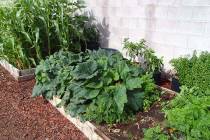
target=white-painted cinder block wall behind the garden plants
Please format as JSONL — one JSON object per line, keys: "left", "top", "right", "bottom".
{"left": 87, "top": 0, "right": 210, "bottom": 68}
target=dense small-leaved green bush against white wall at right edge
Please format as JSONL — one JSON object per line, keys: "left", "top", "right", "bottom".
{"left": 171, "top": 52, "right": 210, "bottom": 92}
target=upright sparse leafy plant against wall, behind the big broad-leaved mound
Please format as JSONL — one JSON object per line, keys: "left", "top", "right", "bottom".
{"left": 124, "top": 39, "right": 163, "bottom": 73}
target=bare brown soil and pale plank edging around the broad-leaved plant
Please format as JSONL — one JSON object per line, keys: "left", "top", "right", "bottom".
{"left": 49, "top": 86, "right": 176, "bottom": 140}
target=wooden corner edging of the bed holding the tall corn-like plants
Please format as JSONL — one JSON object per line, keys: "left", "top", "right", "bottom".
{"left": 0, "top": 60, "right": 35, "bottom": 81}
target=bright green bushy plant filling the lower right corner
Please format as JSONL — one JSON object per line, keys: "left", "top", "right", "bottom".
{"left": 145, "top": 86, "right": 210, "bottom": 140}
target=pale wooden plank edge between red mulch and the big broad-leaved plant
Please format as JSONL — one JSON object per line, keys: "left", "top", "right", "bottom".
{"left": 48, "top": 97, "right": 110, "bottom": 140}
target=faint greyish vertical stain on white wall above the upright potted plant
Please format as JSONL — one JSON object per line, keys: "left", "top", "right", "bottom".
{"left": 145, "top": 4, "right": 156, "bottom": 42}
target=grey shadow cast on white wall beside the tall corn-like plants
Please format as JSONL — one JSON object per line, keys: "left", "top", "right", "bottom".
{"left": 86, "top": 10, "right": 110, "bottom": 48}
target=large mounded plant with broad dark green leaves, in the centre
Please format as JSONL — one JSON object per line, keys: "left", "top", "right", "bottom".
{"left": 33, "top": 49, "right": 159, "bottom": 123}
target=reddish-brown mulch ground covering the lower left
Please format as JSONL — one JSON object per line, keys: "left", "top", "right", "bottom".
{"left": 0, "top": 66, "right": 87, "bottom": 140}
